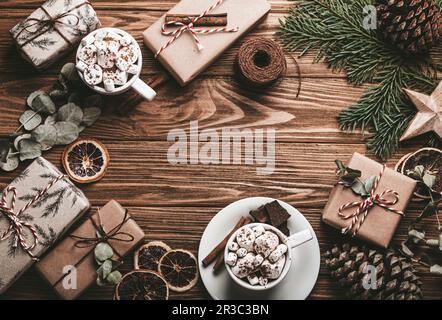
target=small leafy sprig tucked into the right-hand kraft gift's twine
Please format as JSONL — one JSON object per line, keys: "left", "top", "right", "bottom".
{"left": 335, "top": 160, "right": 376, "bottom": 198}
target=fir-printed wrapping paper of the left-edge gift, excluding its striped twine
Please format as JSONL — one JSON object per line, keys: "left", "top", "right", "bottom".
{"left": 0, "top": 158, "right": 90, "bottom": 293}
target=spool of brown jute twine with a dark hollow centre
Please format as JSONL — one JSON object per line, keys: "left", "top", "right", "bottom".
{"left": 236, "top": 38, "right": 287, "bottom": 88}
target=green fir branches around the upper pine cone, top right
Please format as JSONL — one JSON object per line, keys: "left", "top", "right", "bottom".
{"left": 276, "top": 0, "right": 442, "bottom": 159}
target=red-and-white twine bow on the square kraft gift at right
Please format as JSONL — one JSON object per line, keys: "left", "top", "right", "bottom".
{"left": 338, "top": 165, "right": 404, "bottom": 236}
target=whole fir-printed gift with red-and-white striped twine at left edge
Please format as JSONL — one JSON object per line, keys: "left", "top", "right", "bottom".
{"left": 0, "top": 158, "right": 89, "bottom": 293}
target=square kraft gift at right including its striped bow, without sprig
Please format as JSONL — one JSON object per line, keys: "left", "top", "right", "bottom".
{"left": 322, "top": 153, "right": 416, "bottom": 248}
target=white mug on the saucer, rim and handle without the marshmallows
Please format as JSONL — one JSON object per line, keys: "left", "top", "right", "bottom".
{"left": 224, "top": 223, "right": 313, "bottom": 291}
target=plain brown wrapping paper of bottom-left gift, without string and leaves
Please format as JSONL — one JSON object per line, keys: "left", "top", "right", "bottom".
{"left": 36, "top": 200, "right": 144, "bottom": 300}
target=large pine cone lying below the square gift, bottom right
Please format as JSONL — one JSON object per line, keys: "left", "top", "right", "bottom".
{"left": 325, "top": 243, "right": 422, "bottom": 300}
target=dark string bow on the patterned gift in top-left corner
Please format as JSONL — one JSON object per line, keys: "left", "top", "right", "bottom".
{"left": 15, "top": 1, "right": 90, "bottom": 47}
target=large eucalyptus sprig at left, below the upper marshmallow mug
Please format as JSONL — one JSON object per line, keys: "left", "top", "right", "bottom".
{"left": 0, "top": 63, "right": 102, "bottom": 171}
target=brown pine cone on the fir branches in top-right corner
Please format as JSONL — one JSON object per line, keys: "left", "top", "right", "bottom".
{"left": 376, "top": 0, "right": 442, "bottom": 54}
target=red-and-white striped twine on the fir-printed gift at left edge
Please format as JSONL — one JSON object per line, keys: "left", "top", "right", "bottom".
{"left": 0, "top": 175, "right": 66, "bottom": 261}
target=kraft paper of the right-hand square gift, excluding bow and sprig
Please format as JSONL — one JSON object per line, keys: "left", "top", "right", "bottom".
{"left": 322, "top": 153, "right": 416, "bottom": 248}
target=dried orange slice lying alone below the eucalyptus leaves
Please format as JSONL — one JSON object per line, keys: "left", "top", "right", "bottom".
{"left": 62, "top": 138, "right": 109, "bottom": 183}
